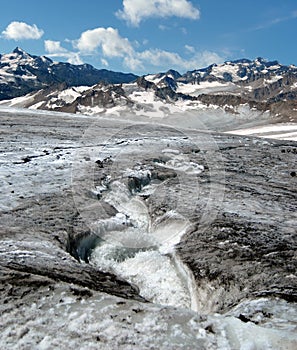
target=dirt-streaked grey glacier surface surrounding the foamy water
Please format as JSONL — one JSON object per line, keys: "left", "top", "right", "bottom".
{"left": 0, "top": 109, "right": 297, "bottom": 349}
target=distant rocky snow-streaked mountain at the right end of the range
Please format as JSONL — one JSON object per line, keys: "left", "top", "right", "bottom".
{"left": 179, "top": 58, "right": 297, "bottom": 102}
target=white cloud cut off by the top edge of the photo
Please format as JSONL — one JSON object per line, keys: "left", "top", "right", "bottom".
{"left": 116, "top": 0, "right": 200, "bottom": 26}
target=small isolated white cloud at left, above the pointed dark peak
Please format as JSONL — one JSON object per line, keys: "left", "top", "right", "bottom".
{"left": 2, "top": 21, "right": 44, "bottom": 40}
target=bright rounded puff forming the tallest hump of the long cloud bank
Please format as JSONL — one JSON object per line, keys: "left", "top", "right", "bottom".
{"left": 75, "top": 27, "right": 133, "bottom": 57}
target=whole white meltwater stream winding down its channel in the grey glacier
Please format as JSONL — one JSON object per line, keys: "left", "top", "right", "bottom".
{"left": 90, "top": 181, "right": 197, "bottom": 311}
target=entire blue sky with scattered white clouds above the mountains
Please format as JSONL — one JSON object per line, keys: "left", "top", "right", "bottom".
{"left": 0, "top": 0, "right": 297, "bottom": 74}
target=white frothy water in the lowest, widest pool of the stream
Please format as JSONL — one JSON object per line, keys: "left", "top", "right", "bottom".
{"left": 92, "top": 243, "right": 191, "bottom": 308}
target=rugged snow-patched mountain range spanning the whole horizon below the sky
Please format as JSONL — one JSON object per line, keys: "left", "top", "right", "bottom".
{"left": 0, "top": 48, "right": 297, "bottom": 128}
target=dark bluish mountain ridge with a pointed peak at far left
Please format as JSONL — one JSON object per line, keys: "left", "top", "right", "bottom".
{"left": 0, "top": 47, "right": 137, "bottom": 100}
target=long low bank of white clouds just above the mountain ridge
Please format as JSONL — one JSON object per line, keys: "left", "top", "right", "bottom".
{"left": 44, "top": 27, "right": 224, "bottom": 73}
